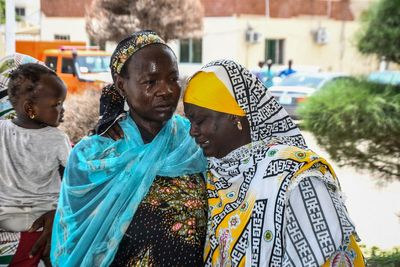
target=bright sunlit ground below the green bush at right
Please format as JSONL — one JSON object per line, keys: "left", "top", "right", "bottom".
{"left": 302, "top": 131, "right": 400, "bottom": 249}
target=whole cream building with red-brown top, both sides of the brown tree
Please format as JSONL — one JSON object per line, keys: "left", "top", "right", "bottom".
{"left": 3, "top": 0, "right": 379, "bottom": 76}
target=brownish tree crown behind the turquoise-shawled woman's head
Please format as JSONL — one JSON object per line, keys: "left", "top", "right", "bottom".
{"left": 86, "top": 0, "right": 203, "bottom": 42}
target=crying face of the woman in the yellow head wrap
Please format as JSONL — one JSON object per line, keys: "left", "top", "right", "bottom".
{"left": 184, "top": 103, "right": 251, "bottom": 158}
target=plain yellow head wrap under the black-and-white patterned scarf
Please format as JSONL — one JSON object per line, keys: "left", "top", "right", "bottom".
{"left": 183, "top": 71, "right": 246, "bottom": 116}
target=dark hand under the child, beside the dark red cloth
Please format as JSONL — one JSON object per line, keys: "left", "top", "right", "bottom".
{"left": 29, "top": 210, "right": 56, "bottom": 266}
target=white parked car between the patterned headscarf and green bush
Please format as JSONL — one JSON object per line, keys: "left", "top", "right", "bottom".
{"left": 268, "top": 72, "right": 350, "bottom": 119}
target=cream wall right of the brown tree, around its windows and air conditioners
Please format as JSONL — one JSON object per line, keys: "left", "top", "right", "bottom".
{"left": 176, "top": 16, "right": 384, "bottom": 75}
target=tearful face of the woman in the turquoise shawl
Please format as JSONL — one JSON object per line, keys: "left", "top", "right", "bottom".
{"left": 117, "top": 44, "right": 181, "bottom": 124}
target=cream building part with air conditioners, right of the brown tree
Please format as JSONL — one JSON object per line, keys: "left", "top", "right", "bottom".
{"left": 173, "top": 0, "right": 378, "bottom": 74}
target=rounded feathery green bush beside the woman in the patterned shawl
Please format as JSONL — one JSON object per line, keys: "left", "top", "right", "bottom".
{"left": 300, "top": 79, "right": 400, "bottom": 180}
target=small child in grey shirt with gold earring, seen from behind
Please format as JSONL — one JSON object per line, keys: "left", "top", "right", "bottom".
{"left": 0, "top": 63, "right": 71, "bottom": 266}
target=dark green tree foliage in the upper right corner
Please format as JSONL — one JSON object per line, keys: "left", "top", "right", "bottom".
{"left": 357, "top": 0, "right": 400, "bottom": 64}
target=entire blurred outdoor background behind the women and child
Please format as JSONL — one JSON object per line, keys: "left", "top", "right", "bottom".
{"left": 0, "top": 0, "right": 400, "bottom": 266}
